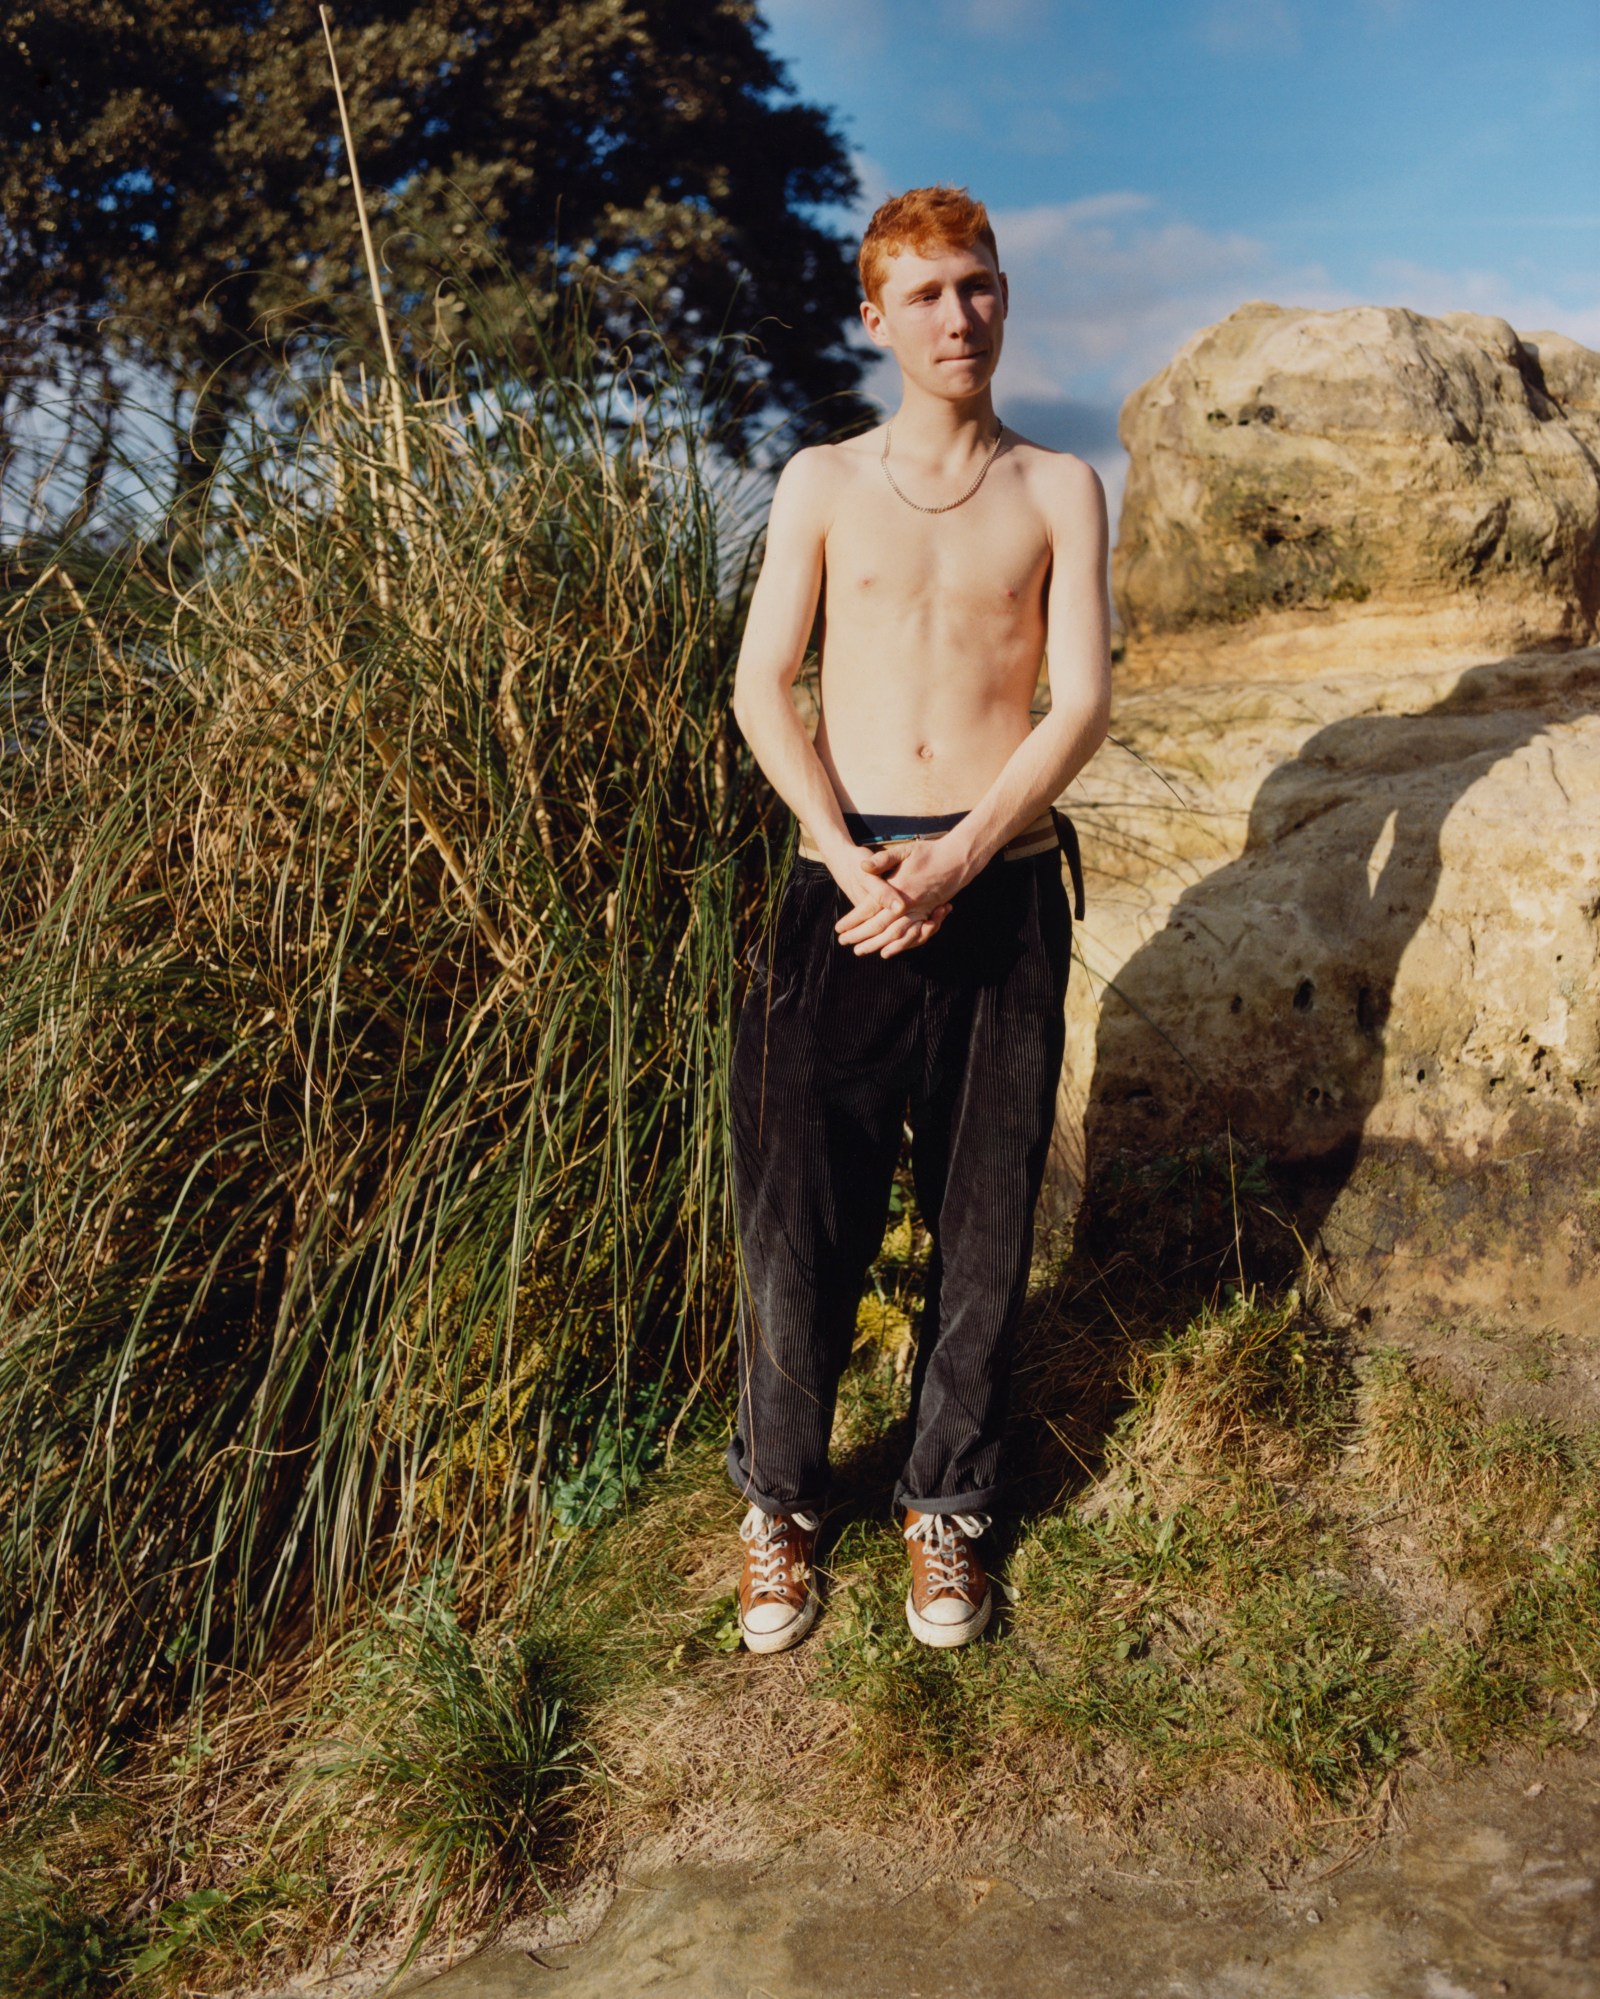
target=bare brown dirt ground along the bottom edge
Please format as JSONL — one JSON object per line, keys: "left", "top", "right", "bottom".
{"left": 247, "top": 1747, "right": 1600, "bottom": 1999}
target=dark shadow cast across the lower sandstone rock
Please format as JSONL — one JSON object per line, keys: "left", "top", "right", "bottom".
{"left": 1018, "top": 652, "right": 1600, "bottom": 1503}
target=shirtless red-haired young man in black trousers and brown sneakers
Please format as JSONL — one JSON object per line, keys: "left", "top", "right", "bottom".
{"left": 728, "top": 188, "right": 1110, "bottom": 1651}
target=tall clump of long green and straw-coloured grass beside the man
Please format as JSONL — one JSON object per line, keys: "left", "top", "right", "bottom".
{"left": 0, "top": 326, "right": 764, "bottom": 1801}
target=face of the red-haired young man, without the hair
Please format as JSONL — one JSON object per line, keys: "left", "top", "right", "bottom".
{"left": 862, "top": 244, "right": 1006, "bottom": 402}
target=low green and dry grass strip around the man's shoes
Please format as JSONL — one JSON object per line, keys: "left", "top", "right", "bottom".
{"left": 0, "top": 1247, "right": 1600, "bottom": 1995}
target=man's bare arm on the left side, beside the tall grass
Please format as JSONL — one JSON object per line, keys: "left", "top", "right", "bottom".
{"left": 734, "top": 450, "right": 946, "bottom": 950}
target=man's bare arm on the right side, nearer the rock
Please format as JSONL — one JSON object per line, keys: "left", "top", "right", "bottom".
{"left": 840, "top": 458, "right": 1112, "bottom": 952}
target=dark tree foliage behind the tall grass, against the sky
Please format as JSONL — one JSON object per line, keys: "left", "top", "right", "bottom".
{"left": 0, "top": 0, "right": 858, "bottom": 445}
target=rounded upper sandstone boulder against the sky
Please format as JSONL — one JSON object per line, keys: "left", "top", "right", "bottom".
{"left": 1112, "top": 304, "right": 1600, "bottom": 678}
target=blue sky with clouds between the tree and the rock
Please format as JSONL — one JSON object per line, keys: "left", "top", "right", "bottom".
{"left": 762, "top": 0, "right": 1600, "bottom": 503}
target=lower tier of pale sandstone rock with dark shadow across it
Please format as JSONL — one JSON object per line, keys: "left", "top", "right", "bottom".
{"left": 1058, "top": 650, "right": 1600, "bottom": 1293}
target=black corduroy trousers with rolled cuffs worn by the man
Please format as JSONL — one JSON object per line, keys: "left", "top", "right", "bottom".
{"left": 728, "top": 854, "right": 1072, "bottom": 1513}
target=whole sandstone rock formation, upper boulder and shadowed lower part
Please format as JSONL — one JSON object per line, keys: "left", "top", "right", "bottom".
{"left": 1054, "top": 306, "right": 1600, "bottom": 1319}
